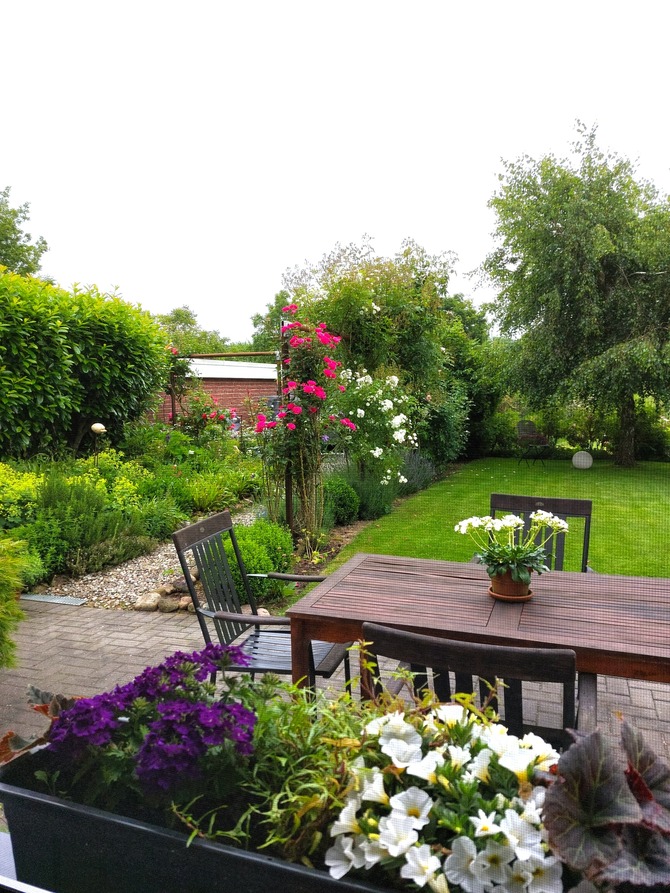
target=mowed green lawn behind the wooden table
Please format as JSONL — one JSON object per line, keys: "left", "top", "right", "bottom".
{"left": 329, "top": 459, "right": 670, "bottom": 577}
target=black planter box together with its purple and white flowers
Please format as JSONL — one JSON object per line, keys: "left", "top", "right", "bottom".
{"left": 0, "top": 645, "right": 572, "bottom": 893}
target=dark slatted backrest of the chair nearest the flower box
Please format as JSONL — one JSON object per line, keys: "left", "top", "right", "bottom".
{"left": 363, "top": 623, "right": 577, "bottom": 743}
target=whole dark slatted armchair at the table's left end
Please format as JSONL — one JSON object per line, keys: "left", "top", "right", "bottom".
{"left": 172, "top": 511, "right": 351, "bottom": 687}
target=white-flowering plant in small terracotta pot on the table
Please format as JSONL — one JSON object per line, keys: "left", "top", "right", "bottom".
{"left": 454, "top": 511, "right": 568, "bottom": 601}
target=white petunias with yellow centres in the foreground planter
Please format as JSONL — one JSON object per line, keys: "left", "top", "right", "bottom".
{"left": 326, "top": 704, "right": 563, "bottom": 893}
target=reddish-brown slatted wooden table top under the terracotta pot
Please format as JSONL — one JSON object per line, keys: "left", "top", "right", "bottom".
{"left": 287, "top": 553, "right": 670, "bottom": 682}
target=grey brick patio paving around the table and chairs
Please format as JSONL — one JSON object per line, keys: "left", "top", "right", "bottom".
{"left": 0, "top": 600, "right": 670, "bottom": 760}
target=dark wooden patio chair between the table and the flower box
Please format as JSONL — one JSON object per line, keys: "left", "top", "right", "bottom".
{"left": 363, "top": 623, "right": 597, "bottom": 749}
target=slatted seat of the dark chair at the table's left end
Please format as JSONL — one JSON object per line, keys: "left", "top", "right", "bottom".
{"left": 230, "top": 629, "right": 347, "bottom": 679}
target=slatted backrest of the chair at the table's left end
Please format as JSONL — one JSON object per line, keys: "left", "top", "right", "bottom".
{"left": 172, "top": 511, "right": 258, "bottom": 644}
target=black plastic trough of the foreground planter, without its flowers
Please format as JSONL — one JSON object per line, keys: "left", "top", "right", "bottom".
{"left": 0, "top": 754, "right": 388, "bottom": 893}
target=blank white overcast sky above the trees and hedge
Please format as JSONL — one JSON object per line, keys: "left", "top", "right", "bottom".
{"left": 0, "top": 0, "right": 670, "bottom": 340}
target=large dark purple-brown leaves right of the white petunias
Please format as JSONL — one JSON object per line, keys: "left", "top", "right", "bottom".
{"left": 544, "top": 723, "right": 670, "bottom": 893}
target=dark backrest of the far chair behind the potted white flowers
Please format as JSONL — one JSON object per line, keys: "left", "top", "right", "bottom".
{"left": 491, "top": 493, "right": 593, "bottom": 573}
